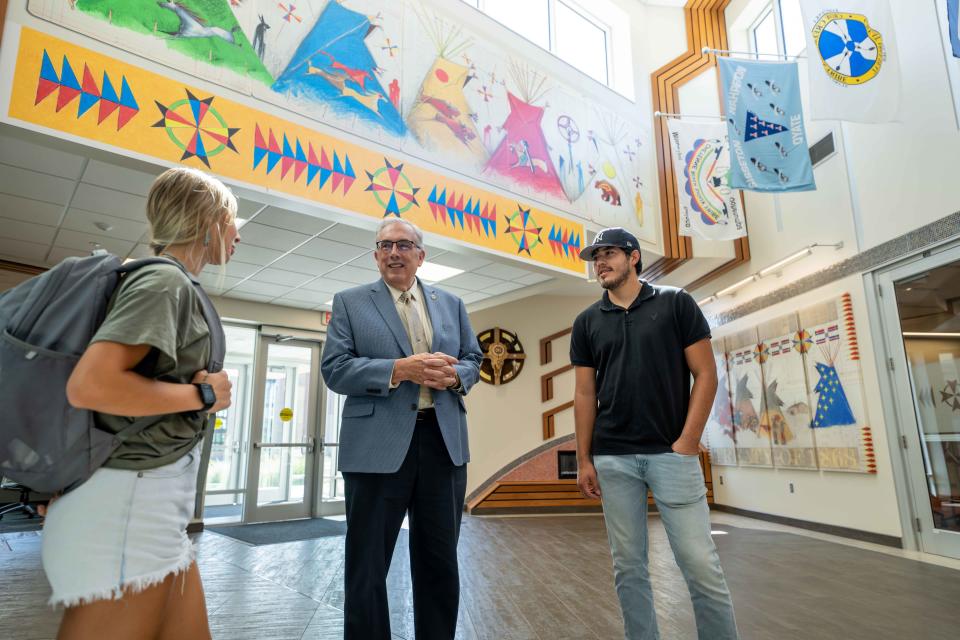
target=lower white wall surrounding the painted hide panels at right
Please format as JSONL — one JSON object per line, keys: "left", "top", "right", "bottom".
{"left": 713, "top": 276, "right": 902, "bottom": 537}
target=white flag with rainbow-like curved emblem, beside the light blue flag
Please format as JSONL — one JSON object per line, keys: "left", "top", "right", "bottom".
{"left": 667, "top": 119, "right": 747, "bottom": 240}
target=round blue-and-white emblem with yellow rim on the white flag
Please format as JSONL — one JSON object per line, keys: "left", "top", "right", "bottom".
{"left": 811, "top": 11, "right": 886, "bottom": 86}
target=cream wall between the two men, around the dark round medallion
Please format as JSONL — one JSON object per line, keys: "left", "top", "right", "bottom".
{"left": 466, "top": 294, "right": 600, "bottom": 494}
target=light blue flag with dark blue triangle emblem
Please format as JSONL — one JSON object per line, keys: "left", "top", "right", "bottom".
{"left": 719, "top": 58, "right": 817, "bottom": 192}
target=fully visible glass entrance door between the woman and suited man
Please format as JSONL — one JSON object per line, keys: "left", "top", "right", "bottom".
{"left": 243, "top": 336, "right": 322, "bottom": 522}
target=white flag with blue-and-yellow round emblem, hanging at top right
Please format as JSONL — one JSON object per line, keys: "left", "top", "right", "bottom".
{"left": 800, "top": 0, "right": 900, "bottom": 122}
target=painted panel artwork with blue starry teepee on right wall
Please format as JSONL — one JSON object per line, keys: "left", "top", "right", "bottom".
{"left": 706, "top": 293, "right": 877, "bottom": 473}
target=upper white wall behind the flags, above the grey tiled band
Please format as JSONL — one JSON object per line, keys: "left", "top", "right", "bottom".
{"left": 684, "top": 0, "right": 960, "bottom": 313}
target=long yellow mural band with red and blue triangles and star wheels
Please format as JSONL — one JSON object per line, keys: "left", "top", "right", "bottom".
{"left": 0, "top": 28, "right": 585, "bottom": 275}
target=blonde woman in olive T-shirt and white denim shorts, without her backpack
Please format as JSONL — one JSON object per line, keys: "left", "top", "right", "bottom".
{"left": 42, "top": 167, "right": 240, "bottom": 640}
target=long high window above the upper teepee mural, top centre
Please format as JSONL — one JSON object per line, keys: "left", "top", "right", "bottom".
{"left": 463, "top": 0, "right": 620, "bottom": 90}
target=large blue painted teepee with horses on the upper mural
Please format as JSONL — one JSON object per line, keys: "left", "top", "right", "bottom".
{"left": 273, "top": 1, "right": 406, "bottom": 135}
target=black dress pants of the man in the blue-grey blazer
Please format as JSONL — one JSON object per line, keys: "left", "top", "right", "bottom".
{"left": 343, "top": 409, "right": 467, "bottom": 640}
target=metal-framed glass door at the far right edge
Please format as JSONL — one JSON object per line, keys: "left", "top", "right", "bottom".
{"left": 881, "top": 249, "right": 960, "bottom": 558}
